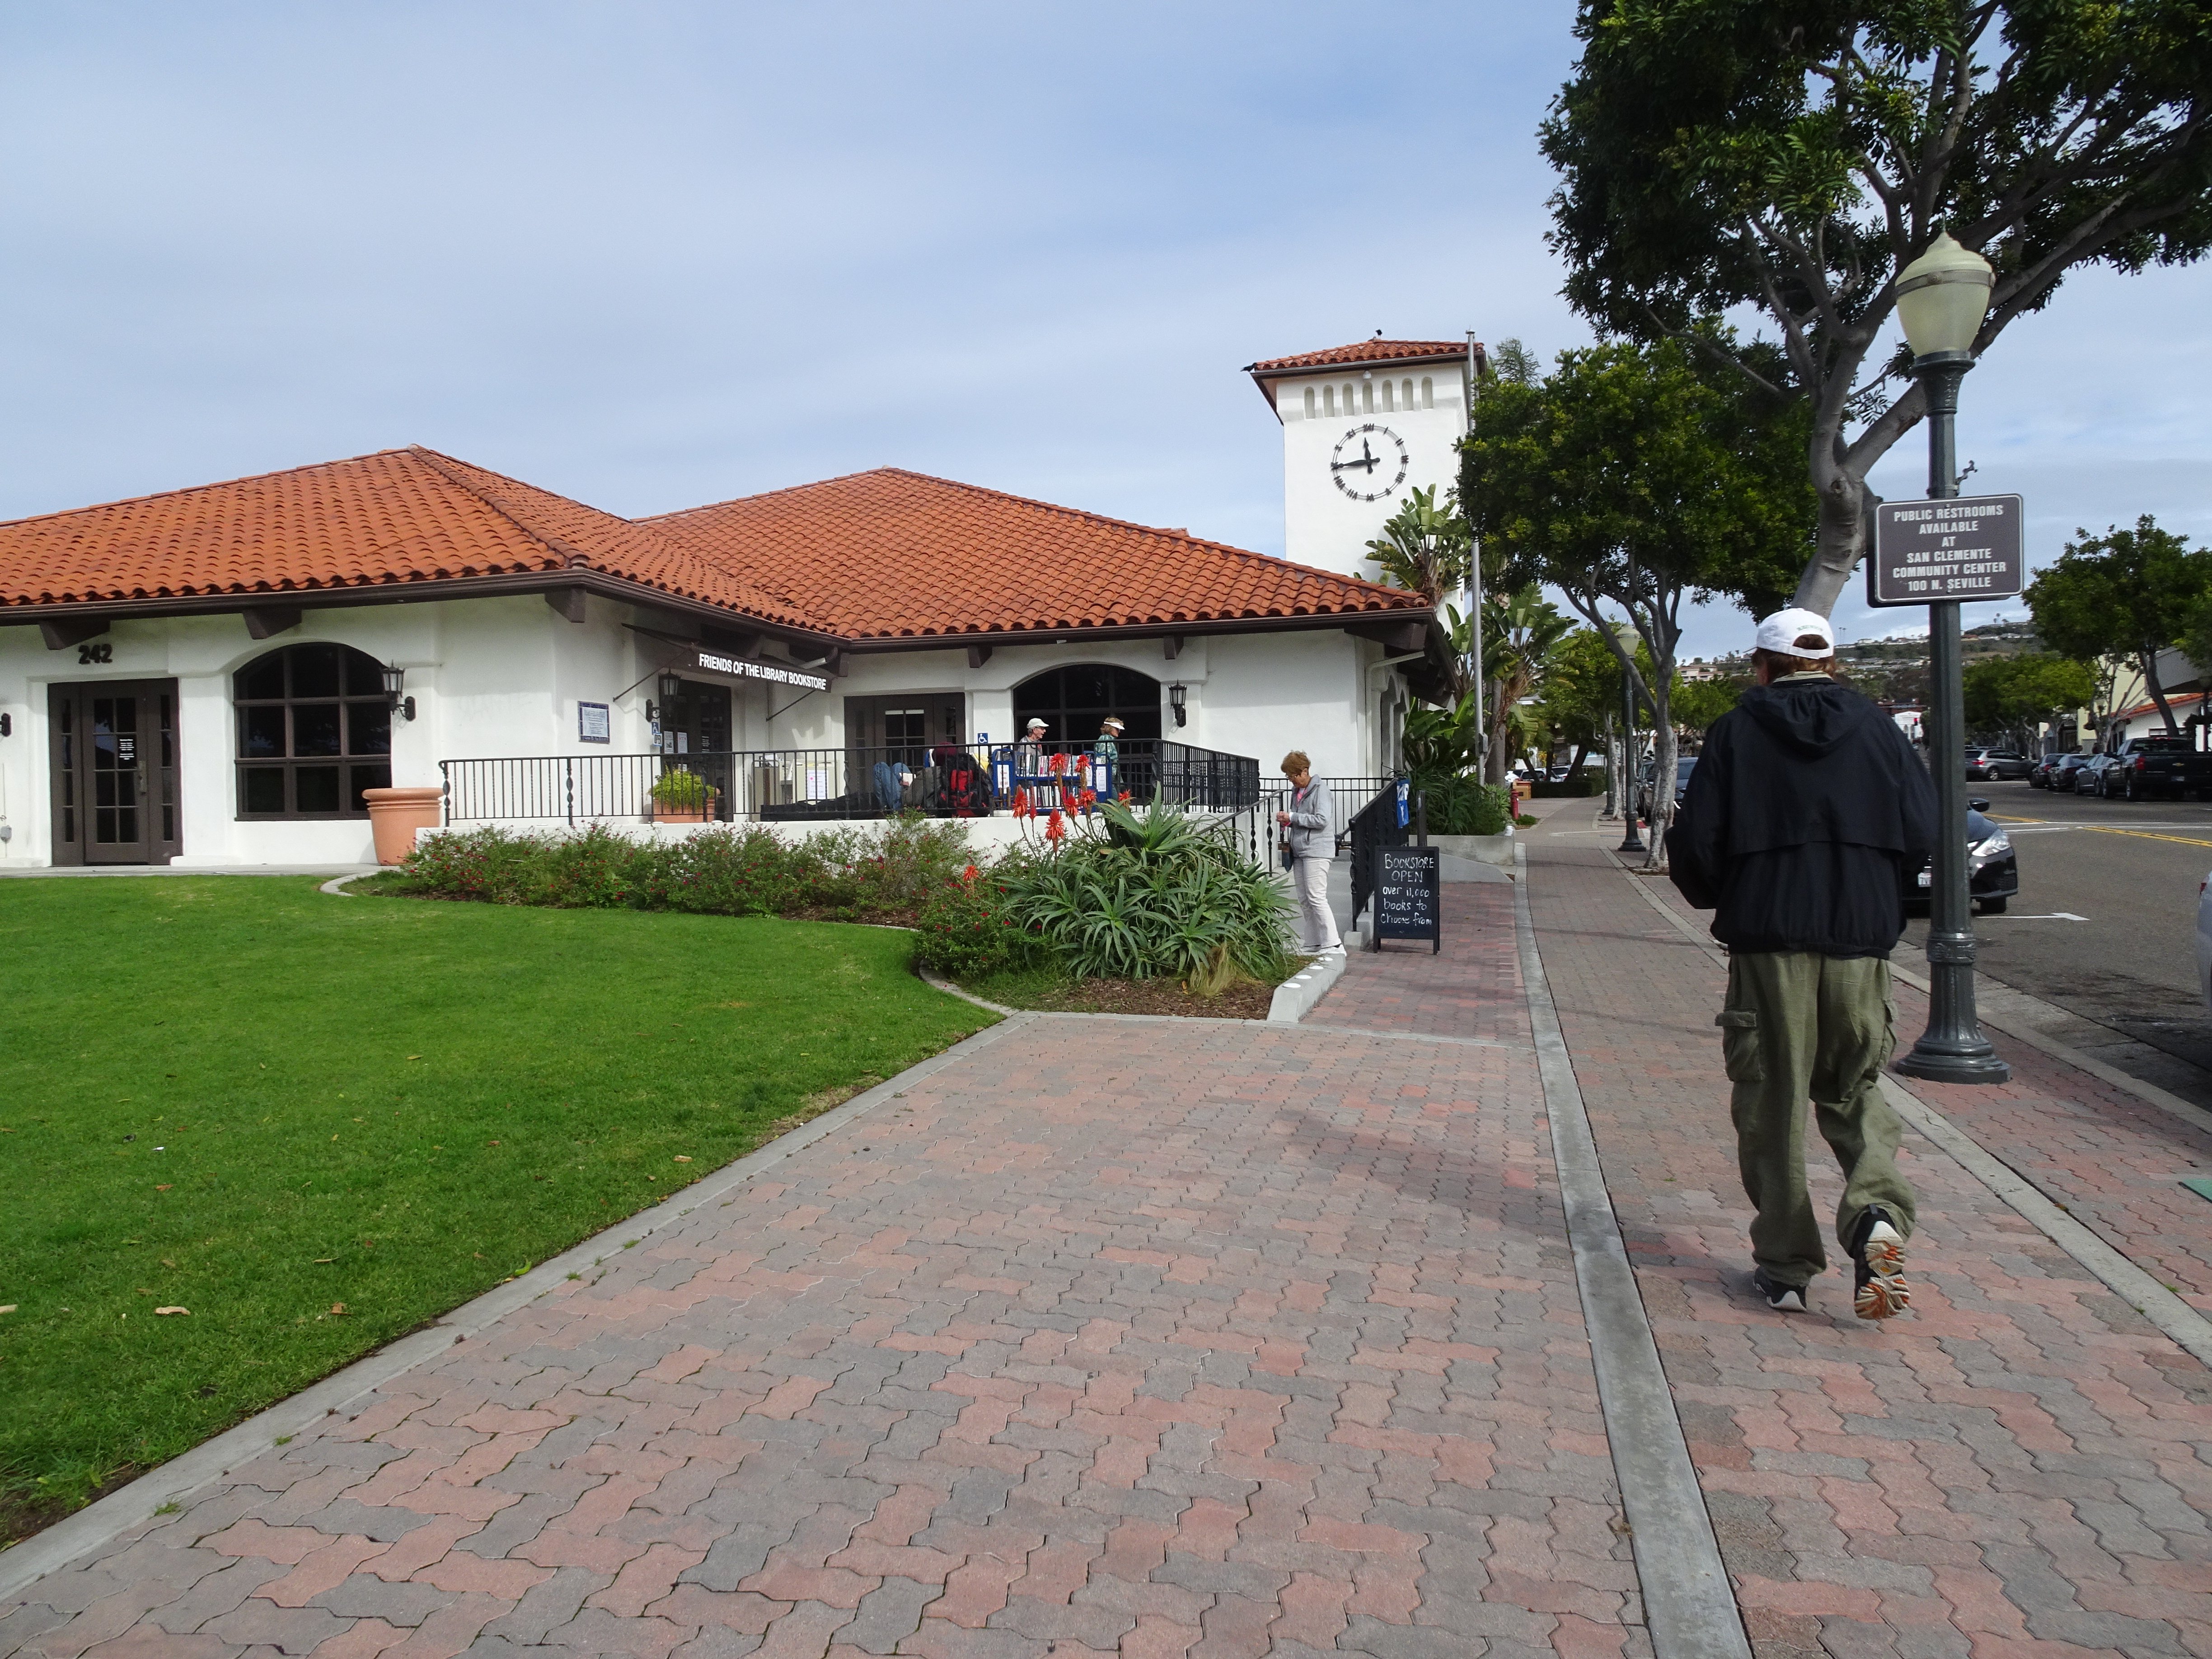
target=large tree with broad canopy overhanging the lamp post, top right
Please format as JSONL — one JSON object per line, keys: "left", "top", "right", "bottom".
{"left": 1542, "top": 0, "right": 2212, "bottom": 615}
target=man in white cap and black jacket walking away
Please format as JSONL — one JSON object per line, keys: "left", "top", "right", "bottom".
{"left": 1666, "top": 610, "right": 1951, "bottom": 1318}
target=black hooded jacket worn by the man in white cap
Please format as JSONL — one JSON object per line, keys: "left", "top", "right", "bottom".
{"left": 1666, "top": 675, "right": 1936, "bottom": 956}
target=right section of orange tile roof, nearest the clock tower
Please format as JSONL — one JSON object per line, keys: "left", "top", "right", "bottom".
{"left": 644, "top": 467, "right": 1427, "bottom": 639}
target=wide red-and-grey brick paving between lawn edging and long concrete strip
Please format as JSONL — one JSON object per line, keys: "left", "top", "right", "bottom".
{"left": 0, "top": 1017, "right": 1648, "bottom": 1659}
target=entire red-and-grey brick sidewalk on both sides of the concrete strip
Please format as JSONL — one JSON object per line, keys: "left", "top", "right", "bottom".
{"left": 0, "top": 836, "right": 2212, "bottom": 1659}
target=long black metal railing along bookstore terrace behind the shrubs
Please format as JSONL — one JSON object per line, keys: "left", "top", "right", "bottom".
{"left": 438, "top": 739, "right": 1261, "bottom": 825}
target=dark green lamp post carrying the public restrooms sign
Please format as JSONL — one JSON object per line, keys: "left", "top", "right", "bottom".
{"left": 1898, "top": 232, "right": 2013, "bottom": 1084}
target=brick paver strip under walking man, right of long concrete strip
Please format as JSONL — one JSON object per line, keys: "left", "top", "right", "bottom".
{"left": 1531, "top": 843, "right": 2212, "bottom": 1659}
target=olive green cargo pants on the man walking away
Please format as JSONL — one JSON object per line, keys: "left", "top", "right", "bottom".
{"left": 1714, "top": 951, "right": 1913, "bottom": 1285}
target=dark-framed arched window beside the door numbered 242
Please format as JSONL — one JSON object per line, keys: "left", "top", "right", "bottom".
{"left": 232, "top": 646, "right": 392, "bottom": 819}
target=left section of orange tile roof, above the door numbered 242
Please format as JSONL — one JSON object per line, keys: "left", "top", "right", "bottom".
{"left": 0, "top": 447, "right": 814, "bottom": 630}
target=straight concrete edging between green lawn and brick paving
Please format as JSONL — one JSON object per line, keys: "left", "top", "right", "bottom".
{"left": 0, "top": 1015, "right": 1037, "bottom": 1602}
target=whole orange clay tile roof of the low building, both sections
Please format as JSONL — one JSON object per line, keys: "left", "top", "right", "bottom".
{"left": 0, "top": 449, "right": 1425, "bottom": 639}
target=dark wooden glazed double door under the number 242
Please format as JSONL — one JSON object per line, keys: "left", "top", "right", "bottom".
{"left": 47, "top": 679, "right": 183, "bottom": 865}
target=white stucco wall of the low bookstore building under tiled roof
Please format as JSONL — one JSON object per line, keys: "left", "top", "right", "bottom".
{"left": 0, "top": 595, "right": 1396, "bottom": 867}
